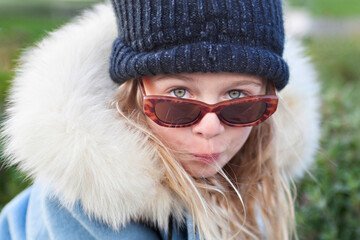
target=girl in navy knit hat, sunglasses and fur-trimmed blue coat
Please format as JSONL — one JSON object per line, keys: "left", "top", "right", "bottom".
{"left": 0, "top": 0, "right": 318, "bottom": 240}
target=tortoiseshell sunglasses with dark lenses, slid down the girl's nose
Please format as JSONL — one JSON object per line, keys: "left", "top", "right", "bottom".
{"left": 139, "top": 78, "right": 278, "bottom": 128}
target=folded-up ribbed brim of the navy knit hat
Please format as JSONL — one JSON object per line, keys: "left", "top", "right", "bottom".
{"left": 110, "top": 39, "right": 289, "bottom": 90}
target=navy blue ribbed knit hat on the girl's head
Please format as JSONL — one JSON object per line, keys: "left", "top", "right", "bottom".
{"left": 110, "top": 0, "right": 289, "bottom": 90}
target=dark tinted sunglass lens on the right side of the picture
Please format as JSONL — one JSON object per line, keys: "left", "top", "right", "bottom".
{"left": 221, "top": 101, "right": 266, "bottom": 124}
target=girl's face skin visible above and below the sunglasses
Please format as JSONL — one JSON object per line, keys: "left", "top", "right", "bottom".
{"left": 143, "top": 73, "right": 265, "bottom": 177}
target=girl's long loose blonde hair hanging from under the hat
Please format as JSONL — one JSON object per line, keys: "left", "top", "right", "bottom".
{"left": 115, "top": 79, "right": 296, "bottom": 240}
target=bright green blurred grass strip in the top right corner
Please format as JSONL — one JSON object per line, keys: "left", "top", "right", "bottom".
{"left": 288, "top": 0, "right": 360, "bottom": 17}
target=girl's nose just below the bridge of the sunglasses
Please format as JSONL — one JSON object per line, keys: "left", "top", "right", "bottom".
{"left": 192, "top": 113, "right": 225, "bottom": 139}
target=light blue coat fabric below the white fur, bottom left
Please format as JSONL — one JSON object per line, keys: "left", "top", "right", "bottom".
{"left": 0, "top": 185, "right": 199, "bottom": 240}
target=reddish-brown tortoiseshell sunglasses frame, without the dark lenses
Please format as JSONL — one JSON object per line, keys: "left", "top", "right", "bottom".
{"left": 139, "top": 78, "right": 279, "bottom": 128}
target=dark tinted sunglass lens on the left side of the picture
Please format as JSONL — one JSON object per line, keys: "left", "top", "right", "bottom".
{"left": 155, "top": 102, "right": 200, "bottom": 125}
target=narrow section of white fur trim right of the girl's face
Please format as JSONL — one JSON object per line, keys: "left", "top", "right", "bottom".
{"left": 274, "top": 38, "right": 320, "bottom": 178}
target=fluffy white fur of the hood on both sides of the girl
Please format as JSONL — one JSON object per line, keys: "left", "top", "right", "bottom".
{"left": 3, "top": 4, "right": 319, "bottom": 231}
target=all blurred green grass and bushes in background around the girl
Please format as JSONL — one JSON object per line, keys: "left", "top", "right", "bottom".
{"left": 0, "top": 0, "right": 360, "bottom": 240}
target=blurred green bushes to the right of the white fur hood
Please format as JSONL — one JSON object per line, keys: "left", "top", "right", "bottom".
{"left": 296, "top": 36, "right": 360, "bottom": 240}
